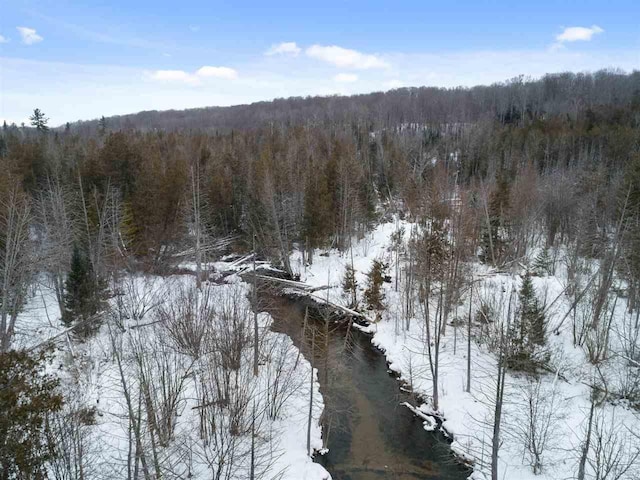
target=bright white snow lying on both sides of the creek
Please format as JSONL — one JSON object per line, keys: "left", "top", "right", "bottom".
{"left": 16, "top": 215, "right": 640, "bottom": 480}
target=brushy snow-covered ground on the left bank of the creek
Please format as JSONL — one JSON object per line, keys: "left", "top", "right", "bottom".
{"left": 16, "top": 264, "right": 331, "bottom": 480}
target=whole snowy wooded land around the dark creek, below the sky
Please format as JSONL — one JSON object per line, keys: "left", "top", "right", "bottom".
{"left": 0, "top": 71, "right": 640, "bottom": 480}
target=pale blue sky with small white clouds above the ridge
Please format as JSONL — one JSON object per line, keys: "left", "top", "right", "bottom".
{"left": 0, "top": 0, "right": 640, "bottom": 125}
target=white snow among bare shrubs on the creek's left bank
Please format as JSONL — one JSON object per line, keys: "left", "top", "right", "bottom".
{"left": 15, "top": 262, "right": 331, "bottom": 480}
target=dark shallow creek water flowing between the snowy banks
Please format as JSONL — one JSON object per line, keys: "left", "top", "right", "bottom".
{"left": 266, "top": 297, "right": 470, "bottom": 480}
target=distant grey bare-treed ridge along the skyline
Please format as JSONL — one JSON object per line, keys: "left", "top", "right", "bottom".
{"left": 46, "top": 71, "right": 640, "bottom": 136}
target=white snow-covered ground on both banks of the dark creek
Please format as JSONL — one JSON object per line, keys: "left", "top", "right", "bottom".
{"left": 16, "top": 221, "right": 640, "bottom": 480}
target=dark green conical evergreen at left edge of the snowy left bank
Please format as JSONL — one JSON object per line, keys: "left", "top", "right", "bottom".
{"left": 62, "top": 245, "right": 105, "bottom": 337}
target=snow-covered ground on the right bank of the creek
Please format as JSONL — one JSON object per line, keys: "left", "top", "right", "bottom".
{"left": 291, "top": 221, "right": 640, "bottom": 480}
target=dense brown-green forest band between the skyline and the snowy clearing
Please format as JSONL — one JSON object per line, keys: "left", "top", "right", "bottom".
{"left": 0, "top": 72, "right": 640, "bottom": 279}
